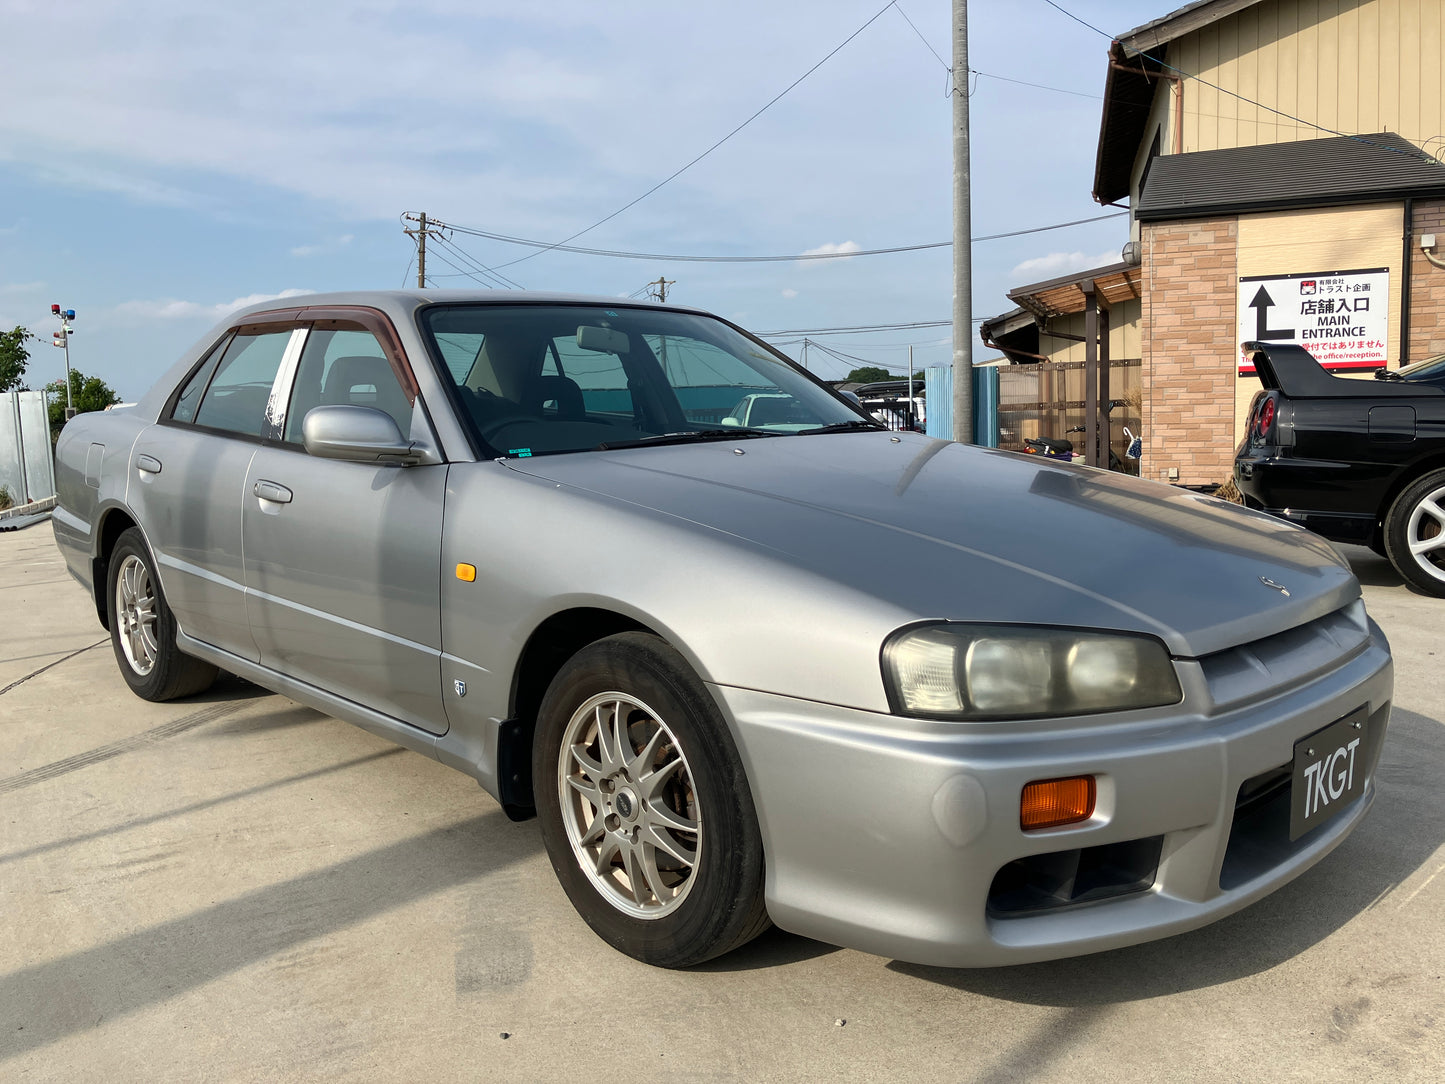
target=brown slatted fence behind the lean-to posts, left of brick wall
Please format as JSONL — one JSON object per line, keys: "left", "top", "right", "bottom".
{"left": 998, "top": 357, "right": 1140, "bottom": 474}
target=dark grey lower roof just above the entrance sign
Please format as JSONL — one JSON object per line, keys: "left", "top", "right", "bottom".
{"left": 1134, "top": 132, "right": 1445, "bottom": 221}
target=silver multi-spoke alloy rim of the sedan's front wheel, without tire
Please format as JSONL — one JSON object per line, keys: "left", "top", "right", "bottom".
{"left": 556, "top": 692, "right": 702, "bottom": 919}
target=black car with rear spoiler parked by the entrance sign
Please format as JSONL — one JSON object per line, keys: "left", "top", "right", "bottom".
{"left": 1234, "top": 343, "right": 1445, "bottom": 597}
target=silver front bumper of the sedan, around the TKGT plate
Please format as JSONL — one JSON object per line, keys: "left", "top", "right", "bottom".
{"left": 714, "top": 623, "right": 1393, "bottom": 967}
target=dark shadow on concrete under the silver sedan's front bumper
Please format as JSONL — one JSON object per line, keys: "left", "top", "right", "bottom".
{"left": 889, "top": 710, "right": 1445, "bottom": 1007}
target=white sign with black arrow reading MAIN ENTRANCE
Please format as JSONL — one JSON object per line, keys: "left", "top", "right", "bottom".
{"left": 1238, "top": 267, "right": 1390, "bottom": 374}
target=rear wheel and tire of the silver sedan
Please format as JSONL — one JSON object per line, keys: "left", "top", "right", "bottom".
{"left": 105, "top": 528, "right": 217, "bottom": 701}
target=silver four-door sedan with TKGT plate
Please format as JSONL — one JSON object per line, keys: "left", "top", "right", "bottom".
{"left": 55, "top": 291, "right": 1393, "bottom": 967}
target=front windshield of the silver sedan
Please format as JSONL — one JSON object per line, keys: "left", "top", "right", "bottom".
{"left": 419, "top": 305, "right": 871, "bottom": 457}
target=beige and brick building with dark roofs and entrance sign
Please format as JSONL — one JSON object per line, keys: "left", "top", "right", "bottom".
{"left": 983, "top": 0, "right": 1445, "bottom": 483}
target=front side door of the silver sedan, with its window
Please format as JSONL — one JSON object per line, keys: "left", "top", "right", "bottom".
{"left": 240, "top": 317, "right": 447, "bottom": 734}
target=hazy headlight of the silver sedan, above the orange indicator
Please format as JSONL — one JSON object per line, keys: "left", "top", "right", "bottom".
{"left": 883, "top": 624, "right": 1183, "bottom": 718}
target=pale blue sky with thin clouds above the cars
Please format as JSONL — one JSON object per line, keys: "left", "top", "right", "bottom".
{"left": 0, "top": 0, "right": 1173, "bottom": 400}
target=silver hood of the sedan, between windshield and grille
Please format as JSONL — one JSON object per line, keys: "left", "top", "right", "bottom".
{"left": 507, "top": 432, "right": 1360, "bottom": 656}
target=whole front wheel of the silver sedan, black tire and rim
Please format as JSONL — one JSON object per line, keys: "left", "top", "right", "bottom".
{"left": 532, "top": 633, "right": 769, "bottom": 967}
